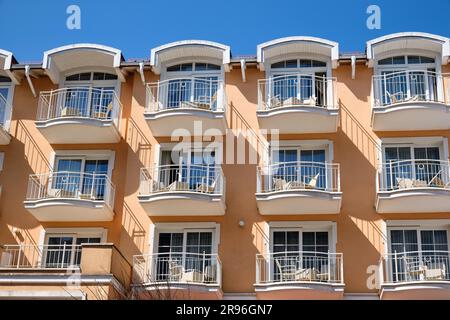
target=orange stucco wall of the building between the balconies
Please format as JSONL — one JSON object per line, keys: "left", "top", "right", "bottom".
{"left": 0, "top": 58, "right": 450, "bottom": 300}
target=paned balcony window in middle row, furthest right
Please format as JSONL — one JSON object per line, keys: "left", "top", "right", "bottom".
{"left": 384, "top": 146, "right": 447, "bottom": 190}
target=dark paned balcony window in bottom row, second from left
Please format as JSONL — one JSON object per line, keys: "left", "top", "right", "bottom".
{"left": 153, "top": 230, "right": 217, "bottom": 282}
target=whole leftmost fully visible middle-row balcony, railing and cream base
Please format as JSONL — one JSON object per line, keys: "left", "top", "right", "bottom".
{"left": 24, "top": 172, "right": 115, "bottom": 222}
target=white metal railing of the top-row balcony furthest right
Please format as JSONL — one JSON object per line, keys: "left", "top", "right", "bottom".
{"left": 372, "top": 70, "right": 450, "bottom": 108}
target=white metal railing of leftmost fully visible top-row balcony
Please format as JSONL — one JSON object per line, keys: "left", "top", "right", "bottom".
{"left": 37, "top": 87, "right": 122, "bottom": 127}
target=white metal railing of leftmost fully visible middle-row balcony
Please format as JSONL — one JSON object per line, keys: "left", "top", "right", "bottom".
{"left": 26, "top": 171, "right": 115, "bottom": 208}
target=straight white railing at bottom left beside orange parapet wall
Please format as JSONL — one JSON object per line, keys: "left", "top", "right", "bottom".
{"left": 0, "top": 244, "right": 81, "bottom": 269}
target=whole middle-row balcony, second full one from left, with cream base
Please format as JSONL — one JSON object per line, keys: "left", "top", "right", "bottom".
{"left": 138, "top": 164, "right": 226, "bottom": 216}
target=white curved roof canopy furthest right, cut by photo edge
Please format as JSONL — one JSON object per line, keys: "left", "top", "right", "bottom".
{"left": 366, "top": 32, "right": 450, "bottom": 67}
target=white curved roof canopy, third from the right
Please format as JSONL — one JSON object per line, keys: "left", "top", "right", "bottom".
{"left": 150, "top": 40, "right": 231, "bottom": 74}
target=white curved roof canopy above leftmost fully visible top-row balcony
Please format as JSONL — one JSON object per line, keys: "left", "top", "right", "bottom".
{"left": 42, "top": 43, "right": 124, "bottom": 83}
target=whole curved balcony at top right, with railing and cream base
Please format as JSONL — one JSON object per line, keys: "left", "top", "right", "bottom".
{"left": 372, "top": 70, "right": 450, "bottom": 131}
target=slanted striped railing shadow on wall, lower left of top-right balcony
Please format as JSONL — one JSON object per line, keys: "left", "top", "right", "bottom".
{"left": 339, "top": 101, "right": 381, "bottom": 168}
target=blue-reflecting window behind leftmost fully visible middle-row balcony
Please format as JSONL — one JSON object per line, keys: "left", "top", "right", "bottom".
{"left": 52, "top": 156, "right": 109, "bottom": 200}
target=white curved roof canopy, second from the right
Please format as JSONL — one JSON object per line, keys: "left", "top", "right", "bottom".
{"left": 256, "top": 36, "right": 339, "bottom": 70}
